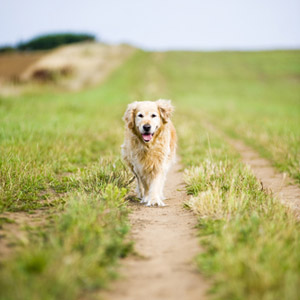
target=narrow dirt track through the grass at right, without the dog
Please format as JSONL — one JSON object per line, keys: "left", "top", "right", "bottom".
{"left": 204, "top": 122, "right": 300, "bottom": 219}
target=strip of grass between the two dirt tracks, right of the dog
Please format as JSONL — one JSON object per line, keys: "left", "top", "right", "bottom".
{"left": 179, "top": 116, "right": 300, "bottom": 300}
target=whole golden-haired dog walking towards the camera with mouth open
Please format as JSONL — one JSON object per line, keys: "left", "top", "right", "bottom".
{"left": 122, "top": 99, "right": 177, "bottom": 206}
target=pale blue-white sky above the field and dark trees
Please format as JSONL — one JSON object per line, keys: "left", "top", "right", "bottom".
{"left": 0, "top": 0, "right": 300, "bottom": 50}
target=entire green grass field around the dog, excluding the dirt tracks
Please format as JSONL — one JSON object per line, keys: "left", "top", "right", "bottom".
{"left": 0, "top": 51, "right": 300, "bottom": 299}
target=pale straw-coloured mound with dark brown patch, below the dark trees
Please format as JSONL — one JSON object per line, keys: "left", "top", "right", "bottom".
{"left": 21, "top": 43, "right": 135, "bottom": 90}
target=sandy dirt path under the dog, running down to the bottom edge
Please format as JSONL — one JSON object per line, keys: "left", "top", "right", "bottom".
{"left": 103, "top": 164, "right": 207, "bottom": 300}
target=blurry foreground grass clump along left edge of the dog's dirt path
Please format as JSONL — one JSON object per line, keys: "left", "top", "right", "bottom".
{"left": 0, "top": 162, "right": 132, "bottom": 300}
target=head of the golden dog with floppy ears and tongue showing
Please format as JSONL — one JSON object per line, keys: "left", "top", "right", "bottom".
{"left": 123, "top": 99, "right": 174, "bottom": 143}
